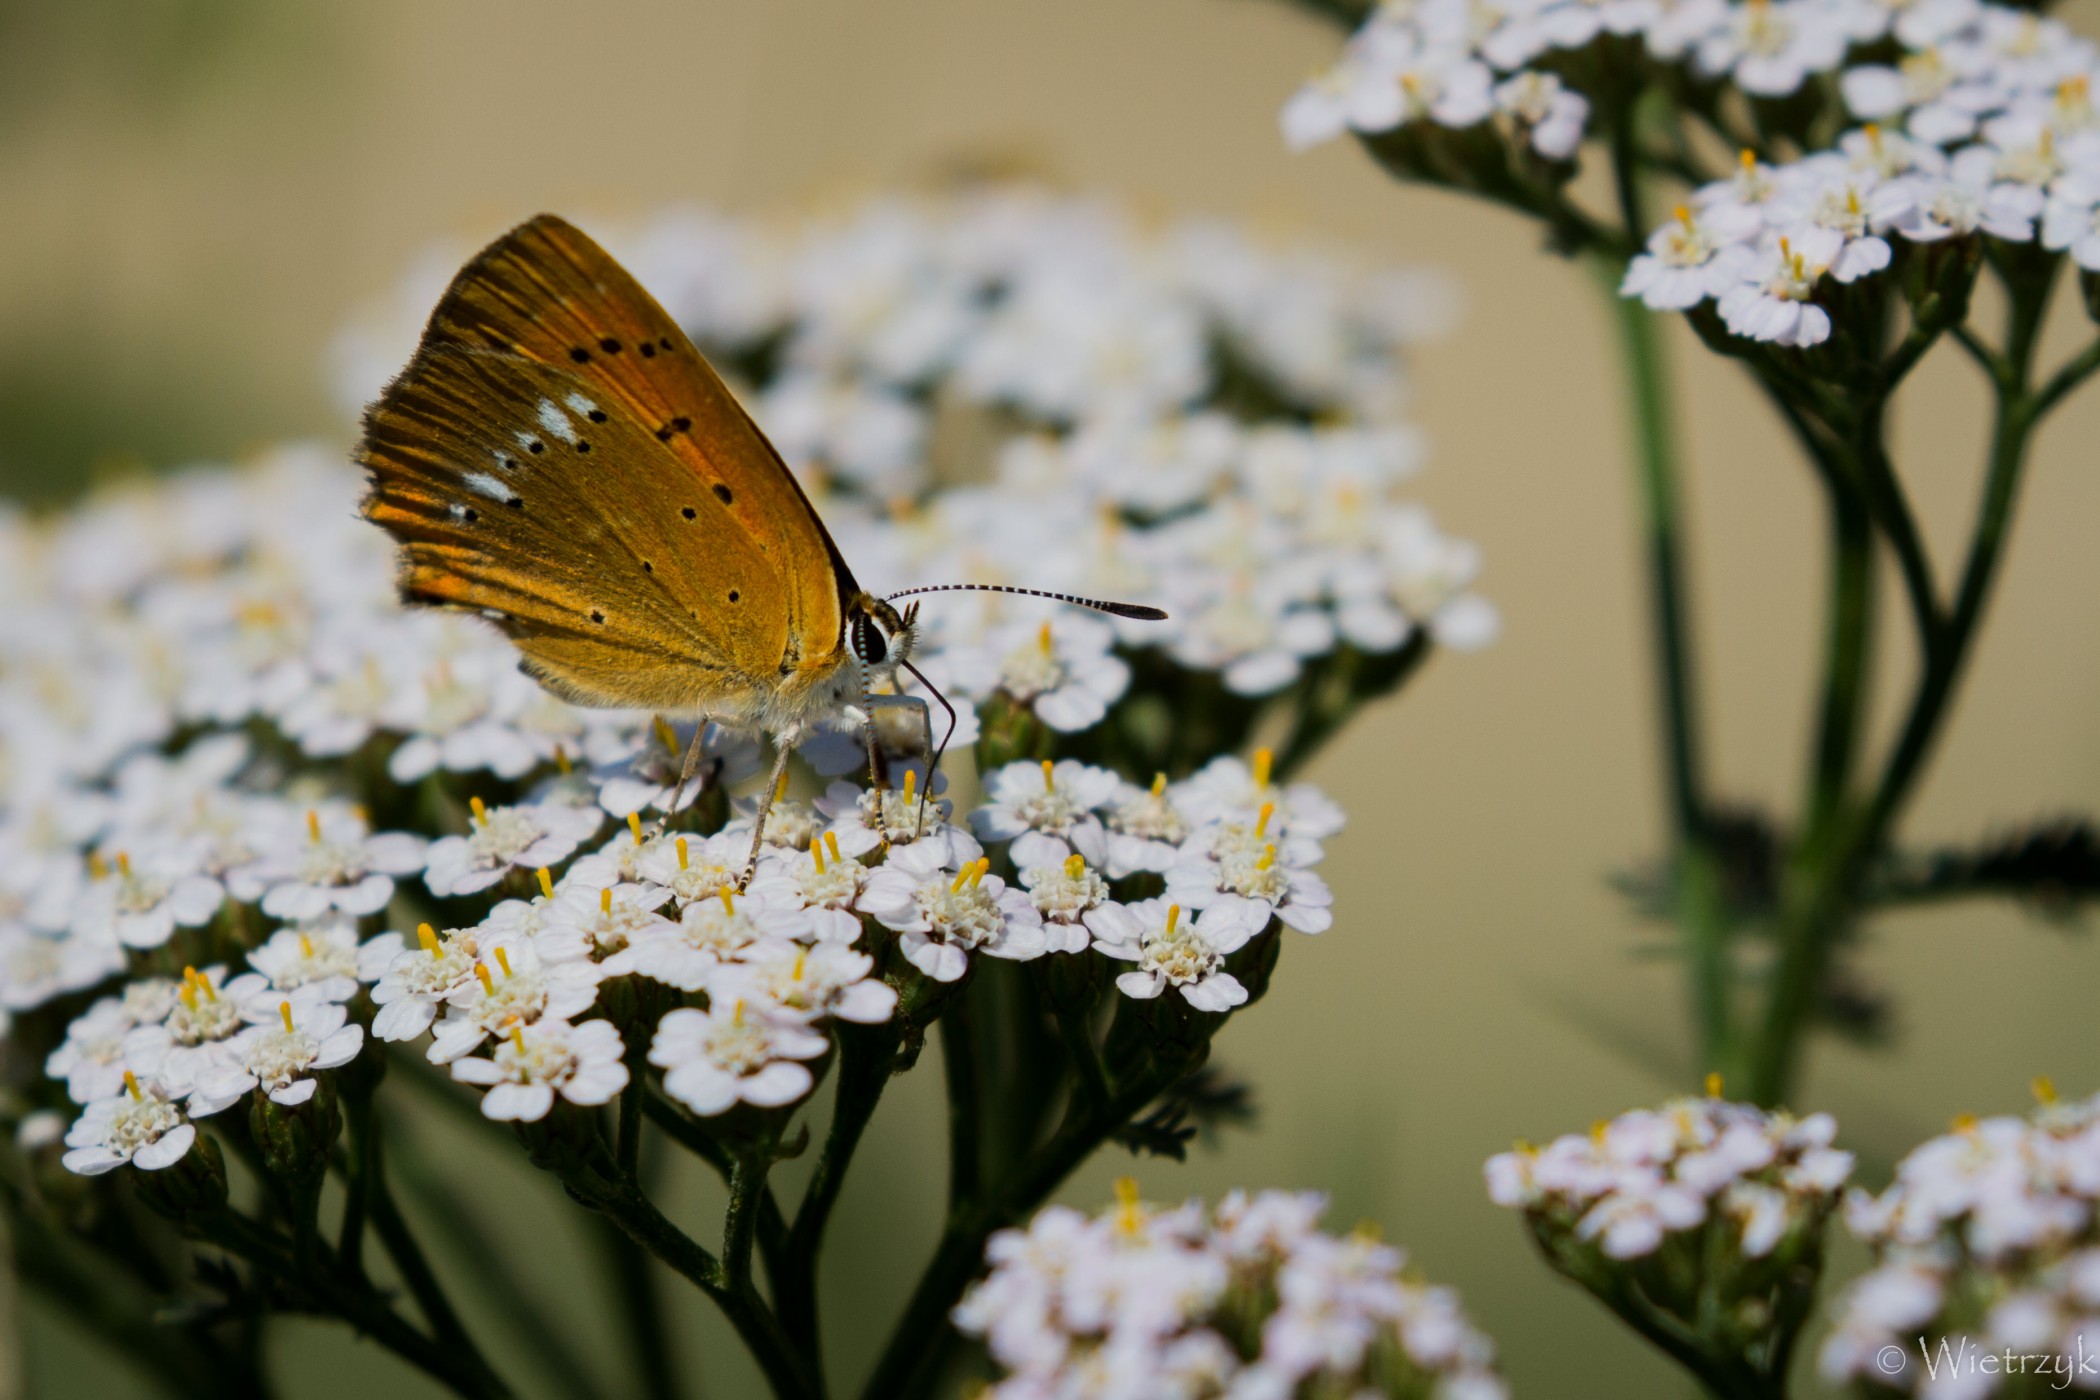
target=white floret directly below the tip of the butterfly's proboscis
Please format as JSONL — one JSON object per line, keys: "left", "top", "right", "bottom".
{"left": 861, "top": 844, "right": 1046, "bottom": 982}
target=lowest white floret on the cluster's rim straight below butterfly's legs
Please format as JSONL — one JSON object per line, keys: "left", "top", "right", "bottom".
{"left": 649, "top": 1001, "right": 832, "bottom": 1117}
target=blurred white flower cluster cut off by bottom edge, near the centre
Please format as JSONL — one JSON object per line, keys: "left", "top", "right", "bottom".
{"left": 953, "top": 1180, "right": 1508, "bottom": 1400}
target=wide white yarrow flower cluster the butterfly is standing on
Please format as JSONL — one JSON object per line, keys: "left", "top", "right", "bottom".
{"left": 0, "top": 451, "right": 1342, "bottom": 1171}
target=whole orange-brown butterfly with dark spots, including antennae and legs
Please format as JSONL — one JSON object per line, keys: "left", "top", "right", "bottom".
{"left": 357, "top": 214, "right": 1166, "bottom": 877}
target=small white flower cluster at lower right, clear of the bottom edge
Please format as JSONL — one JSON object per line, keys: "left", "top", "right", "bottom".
{"left": 1487, "top": 1096, "right": 1852, "bottom": 1259}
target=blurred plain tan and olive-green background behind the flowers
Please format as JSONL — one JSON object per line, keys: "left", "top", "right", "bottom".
{"left": 0, "top": 0, "right": 2100, "bottom": 1400}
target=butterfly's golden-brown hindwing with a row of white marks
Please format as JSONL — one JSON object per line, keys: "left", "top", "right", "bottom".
{"left": 361, "top": 344, "right": 788, "bottom": 709}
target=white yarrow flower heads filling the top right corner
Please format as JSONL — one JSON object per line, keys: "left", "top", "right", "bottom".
{"left": 1283, "top": 0, "right": 2100, "bottom": 346}
